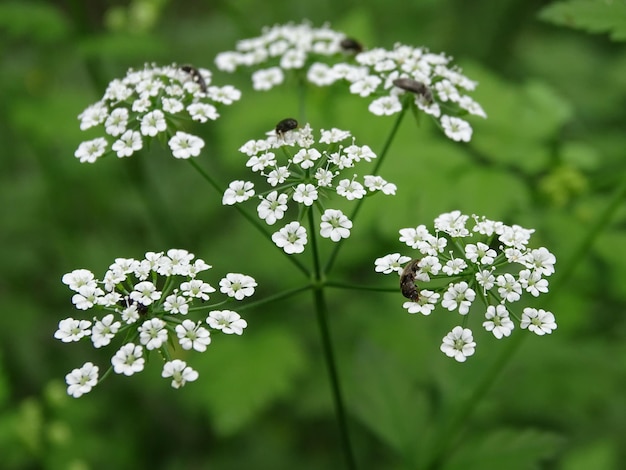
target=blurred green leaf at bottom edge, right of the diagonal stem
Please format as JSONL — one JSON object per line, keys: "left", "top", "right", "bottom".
{"left": 443, "top": 429, "right": 562, "bottom": 470}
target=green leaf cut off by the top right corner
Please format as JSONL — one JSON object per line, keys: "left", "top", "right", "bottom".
{"left": 539, "top": 0, "right": 626, "bottom": 41}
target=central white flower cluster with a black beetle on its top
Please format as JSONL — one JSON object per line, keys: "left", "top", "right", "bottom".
{"left": 222, "top": 121, "right": 396, "bottom": 254}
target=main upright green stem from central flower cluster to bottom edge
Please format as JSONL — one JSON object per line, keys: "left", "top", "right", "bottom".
{"left": 308, "top": 210, "right": 357, "bottom": 470}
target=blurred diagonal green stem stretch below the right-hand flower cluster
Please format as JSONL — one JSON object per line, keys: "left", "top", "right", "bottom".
{"left": 424, "top": 332, "right": 527, "bottom": 470}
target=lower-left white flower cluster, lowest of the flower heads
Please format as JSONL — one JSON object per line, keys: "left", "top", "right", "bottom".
{"left": 54, "top": 249, "right": 257, "bottom": 397}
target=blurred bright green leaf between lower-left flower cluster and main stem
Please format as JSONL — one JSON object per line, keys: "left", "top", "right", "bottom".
{"left": 193, "top": 327, "right": 305, "bottom": 435}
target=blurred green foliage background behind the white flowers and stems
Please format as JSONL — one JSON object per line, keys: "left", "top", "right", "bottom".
{"left": 0, "top": 0, "right": 626, "bottom": 470}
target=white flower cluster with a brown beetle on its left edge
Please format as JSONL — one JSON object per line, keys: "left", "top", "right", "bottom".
{"left": 375, "top": 211, "right": 557, "bottom": 362}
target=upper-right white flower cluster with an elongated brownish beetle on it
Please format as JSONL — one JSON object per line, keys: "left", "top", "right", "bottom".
{"left": 308, "top": 44, "right": 487, "bottom": 142}
